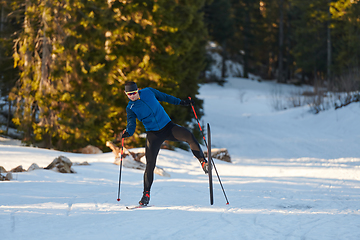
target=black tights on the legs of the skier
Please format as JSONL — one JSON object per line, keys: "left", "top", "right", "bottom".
{"left": 144, "top": 122, "right": 204, "bottom": 192}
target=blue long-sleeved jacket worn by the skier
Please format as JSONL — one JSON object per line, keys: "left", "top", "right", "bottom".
{"left": 126, "top": 87, "right": 181, "bottom": 136}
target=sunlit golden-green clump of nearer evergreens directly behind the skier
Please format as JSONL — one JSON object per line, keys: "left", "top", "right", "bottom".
{"left": 9, "top": 0, "right": 206, "bottom": 150}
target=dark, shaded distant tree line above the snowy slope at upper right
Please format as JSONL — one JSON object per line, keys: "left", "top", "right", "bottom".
{"left": 205, "top": 0, "right": 360, "bottom": 90}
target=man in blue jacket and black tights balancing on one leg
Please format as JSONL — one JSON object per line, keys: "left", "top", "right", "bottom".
{"left": 114, "top": 82, "right": 208, "bottom": 206}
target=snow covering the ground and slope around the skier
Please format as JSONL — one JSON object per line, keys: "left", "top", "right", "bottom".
{"left": 0, "top": 78, "right": 360, "bottom": 240}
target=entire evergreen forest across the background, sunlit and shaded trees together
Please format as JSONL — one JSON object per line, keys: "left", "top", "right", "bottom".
{"left": 0, "top": 0, "right": 360, "bottom": 151}
